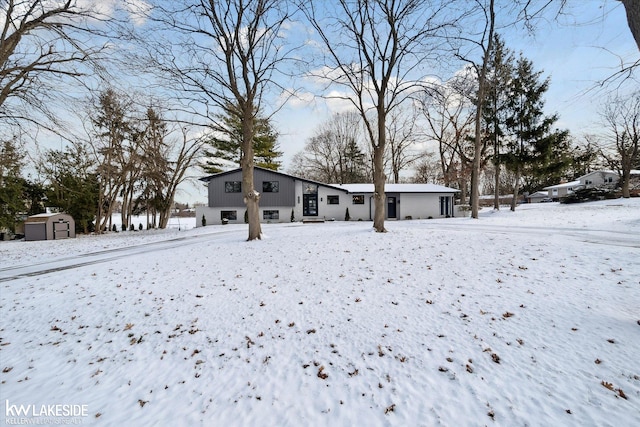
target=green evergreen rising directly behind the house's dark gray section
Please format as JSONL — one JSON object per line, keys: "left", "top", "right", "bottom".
{"left": 202, "top": 108, "right": 282, "bottom": 174}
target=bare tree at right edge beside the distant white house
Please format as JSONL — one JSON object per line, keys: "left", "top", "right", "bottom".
{"left": 602, "top": 92, "right": 640, "bottom": 197}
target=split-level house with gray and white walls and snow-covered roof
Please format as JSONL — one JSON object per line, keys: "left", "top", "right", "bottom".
{"left": 196, "top": 167, "right": 458, "bottom": 226}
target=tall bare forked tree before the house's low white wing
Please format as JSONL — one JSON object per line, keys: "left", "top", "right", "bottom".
{"left": 300, "top": 0, "right": 446, "bottom": 232}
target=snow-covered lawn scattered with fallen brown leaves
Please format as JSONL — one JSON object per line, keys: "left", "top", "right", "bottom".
{"left": 0, "top": 199, "right": 640, "bottom": 426}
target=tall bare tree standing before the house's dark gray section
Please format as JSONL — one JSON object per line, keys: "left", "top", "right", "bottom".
{"left": 141, "top": 0, "right": 290, "bottom": 240}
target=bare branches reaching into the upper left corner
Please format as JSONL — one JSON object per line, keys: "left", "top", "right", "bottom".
{"left": 0, "top": 0, "right": 110, "bottom": 129}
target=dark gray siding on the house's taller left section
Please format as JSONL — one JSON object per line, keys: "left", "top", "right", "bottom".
{"left": 209, "top": 169, "right": 295, "bottom": 208}
